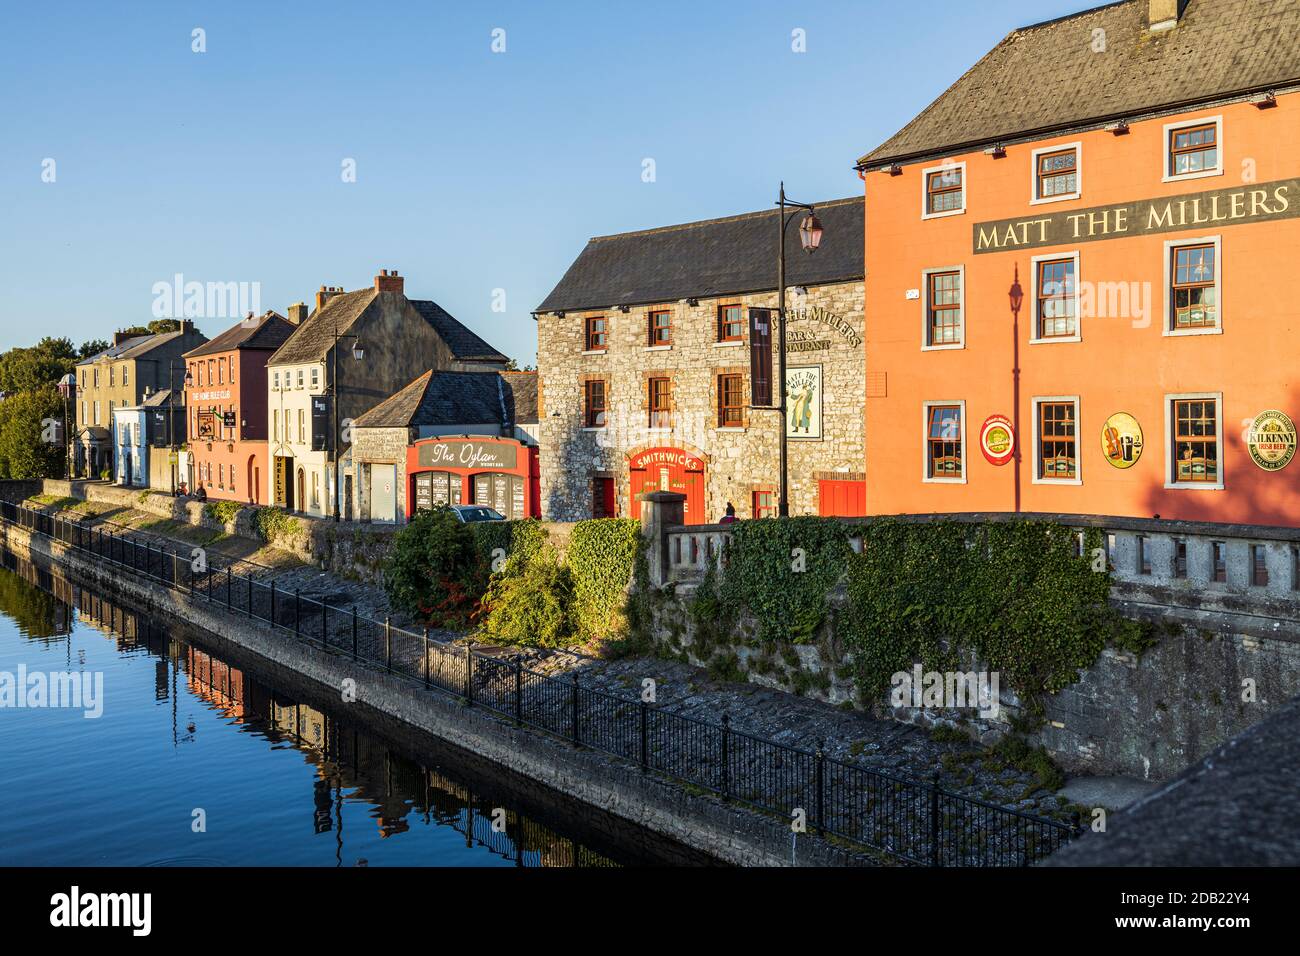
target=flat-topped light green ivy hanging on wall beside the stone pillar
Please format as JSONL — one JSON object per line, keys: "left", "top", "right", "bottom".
{"left": 568, "top": 518, "right": 641, "bottom": 641}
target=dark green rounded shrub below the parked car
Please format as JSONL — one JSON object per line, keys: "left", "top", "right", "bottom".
{"left": 384, "top": 505, "right": 488, "bottom": 628}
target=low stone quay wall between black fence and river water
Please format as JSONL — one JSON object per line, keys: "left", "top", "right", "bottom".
{"left": 0, "top": 523, "right": 883, "bottom": 866}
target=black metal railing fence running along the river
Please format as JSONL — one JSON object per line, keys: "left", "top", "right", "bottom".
{"left": 0, "top": 501, "right": 1078, "bottom": 866}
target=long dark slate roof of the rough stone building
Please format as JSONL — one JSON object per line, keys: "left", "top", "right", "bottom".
{"left": 537, "top": 196, "right": 865, "bottom": 312}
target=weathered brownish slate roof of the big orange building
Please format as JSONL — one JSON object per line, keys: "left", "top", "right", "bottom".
{"left": 858, "top": 0, "right": 1300, "bottom": 165}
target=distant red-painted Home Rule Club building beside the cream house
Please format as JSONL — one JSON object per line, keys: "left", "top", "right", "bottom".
{"left": 185, "top": 312, "right": 295, "bottom": 505}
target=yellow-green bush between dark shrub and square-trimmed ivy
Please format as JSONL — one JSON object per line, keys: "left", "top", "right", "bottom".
{"left": 481, "top": 550, "right": 575, "bottom": 648}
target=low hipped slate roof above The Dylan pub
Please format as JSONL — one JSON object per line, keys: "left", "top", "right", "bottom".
{"left": 352, "top": 371, "right": 525, "bottom": 428}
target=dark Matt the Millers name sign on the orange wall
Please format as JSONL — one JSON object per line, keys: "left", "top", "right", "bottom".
{"left": 972, "top": 178, "right": 1300, "bottom": 255}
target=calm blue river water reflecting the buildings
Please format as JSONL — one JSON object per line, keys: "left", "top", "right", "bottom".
{"left": 0, "top": 554, "right": 691, "bottom": 866}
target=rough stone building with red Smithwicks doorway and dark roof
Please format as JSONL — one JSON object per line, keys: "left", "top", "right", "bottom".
{"left": 536, "top": 200, "right": 866, "bottom": 524}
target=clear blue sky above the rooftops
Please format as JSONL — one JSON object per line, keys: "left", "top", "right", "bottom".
{"left": 0, "top": 0, "right": 1093, "bottom": 364}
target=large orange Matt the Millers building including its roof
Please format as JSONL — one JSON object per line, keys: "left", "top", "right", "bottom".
{"left": 859, "top": 0, "right": 1300, "bottom": 525}
